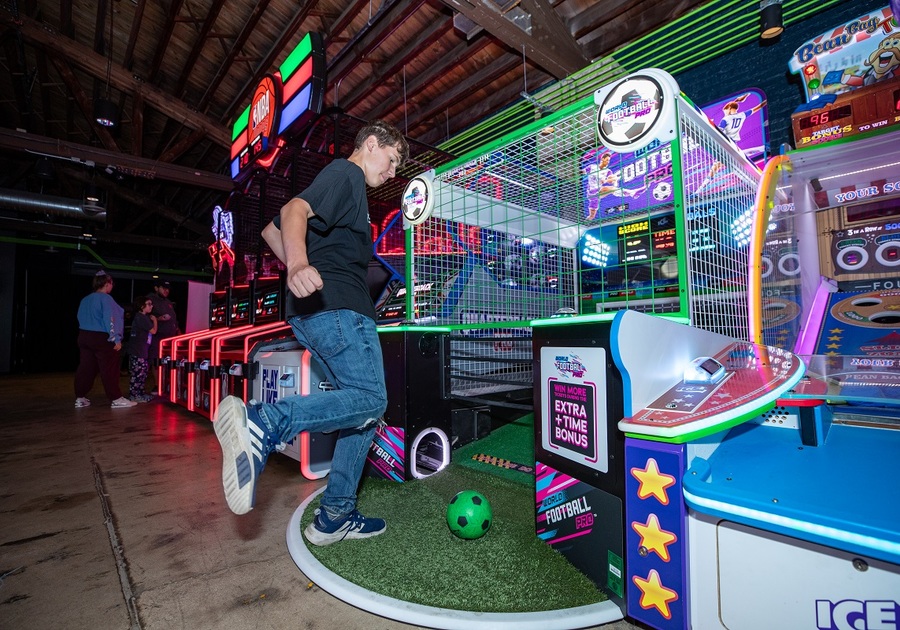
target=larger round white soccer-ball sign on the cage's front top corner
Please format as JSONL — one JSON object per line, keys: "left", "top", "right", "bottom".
{"left": 594, "top": 69, "right": 678, "bottom": 153}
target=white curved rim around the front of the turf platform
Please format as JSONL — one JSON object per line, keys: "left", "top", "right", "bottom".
{"left": 287, "top": 488, "right": 622, "bottom": 630}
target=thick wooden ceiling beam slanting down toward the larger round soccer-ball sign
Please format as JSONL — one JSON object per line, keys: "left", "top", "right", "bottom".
{"left": 441, "top": 0, "right": 590, "bottom": 79}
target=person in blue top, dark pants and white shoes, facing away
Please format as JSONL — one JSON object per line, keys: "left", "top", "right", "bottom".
{"left": 75, "top": 271, "right": 137, "bottom": 408}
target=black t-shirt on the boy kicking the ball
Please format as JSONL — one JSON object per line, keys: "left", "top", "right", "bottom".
{"left": 275, "top": 159, "right": 375, "bottom": 319}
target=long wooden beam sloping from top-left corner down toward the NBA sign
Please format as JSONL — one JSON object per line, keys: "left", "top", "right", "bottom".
{"left": 0, "top": 12, "right": 231, "bottom": 149}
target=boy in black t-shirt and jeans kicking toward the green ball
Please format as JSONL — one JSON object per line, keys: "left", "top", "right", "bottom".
{"left": 213, "top": 121, "right": 409, "bottom": 546}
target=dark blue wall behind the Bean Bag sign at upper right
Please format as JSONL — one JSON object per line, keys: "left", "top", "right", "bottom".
{"left": 675, "top": 0, "right": 887, "bottom": 154}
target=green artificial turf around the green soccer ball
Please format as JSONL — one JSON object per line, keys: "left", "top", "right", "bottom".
{"left": 301, "top": 464, "right": 606, "bottom": 613}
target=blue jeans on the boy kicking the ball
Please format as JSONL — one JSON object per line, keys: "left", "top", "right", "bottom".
{"left": 248, "top": 309, "right": 387, "bottom": 518}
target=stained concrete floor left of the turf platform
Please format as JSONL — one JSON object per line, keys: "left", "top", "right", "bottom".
{"left": 0, "top": 374, "right": 638, "bottom": 630}
